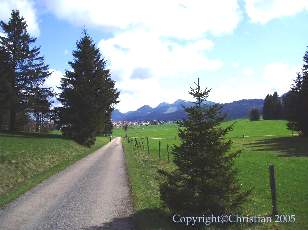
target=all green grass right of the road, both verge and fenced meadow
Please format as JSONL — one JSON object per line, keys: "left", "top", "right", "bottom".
{"left": 114, "top": 120, "right": 308, "bottom": 229}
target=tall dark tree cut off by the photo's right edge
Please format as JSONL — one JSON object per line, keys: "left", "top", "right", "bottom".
{"left": 286, "top": 50, "right": 308, "bottom": 136}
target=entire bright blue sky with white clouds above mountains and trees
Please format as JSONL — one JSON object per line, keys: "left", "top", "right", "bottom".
{"left": 0, "top": 0, "right": 308, "bottom": 112}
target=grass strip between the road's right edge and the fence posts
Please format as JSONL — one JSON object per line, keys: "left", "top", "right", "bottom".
{"left": 123, "top": 142, "right": 176, "bottom": 230}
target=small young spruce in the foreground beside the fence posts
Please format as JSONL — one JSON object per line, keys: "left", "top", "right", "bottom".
{"left": 160, "top": 79, "right": 249, "bottom": 215}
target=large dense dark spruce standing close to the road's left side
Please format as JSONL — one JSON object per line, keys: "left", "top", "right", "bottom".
{"left": 58, "top": 31, "right": 119, "bottom": 146}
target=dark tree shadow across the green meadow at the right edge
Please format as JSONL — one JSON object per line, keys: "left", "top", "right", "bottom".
{"left": 246, "top": 137, "right": 308, "bottom": 157}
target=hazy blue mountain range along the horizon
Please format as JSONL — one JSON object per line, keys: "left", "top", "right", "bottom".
{"left": 112, "top": 99, "right": 264, "bottom": 121}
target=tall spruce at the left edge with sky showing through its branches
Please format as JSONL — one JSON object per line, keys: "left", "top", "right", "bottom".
{"left": 0, "top": 10, "right": 50, "bottom": 131}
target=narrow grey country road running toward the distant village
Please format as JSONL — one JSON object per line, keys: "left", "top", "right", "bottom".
{"left": 0, "top": 138, "right": 133, "bottom": 230}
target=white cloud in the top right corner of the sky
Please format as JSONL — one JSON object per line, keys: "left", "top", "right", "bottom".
{"left": 245, "top": 0, "right": 308, "bottom": 24}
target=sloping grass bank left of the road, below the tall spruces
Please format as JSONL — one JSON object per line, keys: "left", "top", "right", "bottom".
{"left": 0, "top": 133, "right": 109, "bottom": 207}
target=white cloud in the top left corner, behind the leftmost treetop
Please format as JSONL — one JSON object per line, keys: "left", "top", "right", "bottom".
{"left": 0, "top": 0, "right": 40, "bottom": 36}
